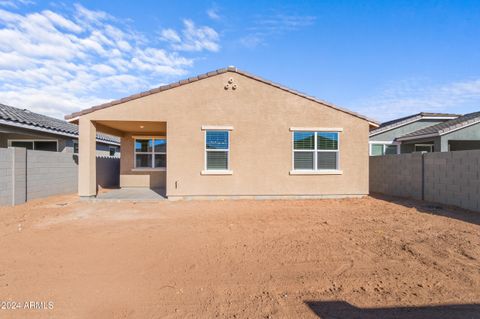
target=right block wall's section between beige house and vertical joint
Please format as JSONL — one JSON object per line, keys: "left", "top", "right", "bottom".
{"left": 370, "top": 153, "right": 422, "bottom": 199}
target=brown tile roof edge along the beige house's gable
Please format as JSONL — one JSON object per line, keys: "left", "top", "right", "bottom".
{"left": 65, "top": 66, "right": 379, "bottom": 126}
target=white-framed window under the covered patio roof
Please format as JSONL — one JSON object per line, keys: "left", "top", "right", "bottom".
{"left": 134, "top": 137, "right": 167, "bottom": 170}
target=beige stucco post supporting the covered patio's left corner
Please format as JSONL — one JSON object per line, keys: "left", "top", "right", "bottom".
{"left": 78, "top": 117, "right": 97, "bottom": 197}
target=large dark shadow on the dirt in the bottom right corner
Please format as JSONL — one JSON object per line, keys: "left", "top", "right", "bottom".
{"left": 305, "top": 301, "right": 480, "bottom": 319}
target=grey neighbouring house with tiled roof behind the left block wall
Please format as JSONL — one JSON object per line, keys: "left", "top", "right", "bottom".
{"left": 0, "top": 104, "right": 120, "bottom": 157}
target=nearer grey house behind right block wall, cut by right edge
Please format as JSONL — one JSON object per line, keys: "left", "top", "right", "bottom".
{"left": 396, "top": 112, "right": 480, "bottom": 153}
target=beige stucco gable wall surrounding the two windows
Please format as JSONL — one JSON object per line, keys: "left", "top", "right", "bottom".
{"left": 80, "top": 72, "right": 369, "bottom": 197}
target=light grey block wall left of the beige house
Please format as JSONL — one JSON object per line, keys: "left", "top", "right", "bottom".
{"left": 0, "top": 148, "right": 120, "bottom": 205}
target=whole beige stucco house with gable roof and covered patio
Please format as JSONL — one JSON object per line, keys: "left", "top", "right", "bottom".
{"left": 66, "top": 67, "right": 378, "bottom": 199}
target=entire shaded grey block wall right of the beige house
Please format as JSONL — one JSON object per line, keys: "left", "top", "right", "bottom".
{"left": 370, "top": 150, "right": 480, "bottom": 211}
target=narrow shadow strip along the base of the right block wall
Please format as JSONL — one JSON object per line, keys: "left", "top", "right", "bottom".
{"left": 370, "top": 194, "right": 480, "bottom": 225}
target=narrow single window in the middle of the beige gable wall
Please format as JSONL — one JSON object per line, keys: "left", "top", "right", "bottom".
{"left": 205, "top": 130, "right": 230, "bottom": 171}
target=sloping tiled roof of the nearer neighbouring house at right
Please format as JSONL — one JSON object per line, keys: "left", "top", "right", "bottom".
{"left": 397, "top": 112, "right": 480, "bottom": 141}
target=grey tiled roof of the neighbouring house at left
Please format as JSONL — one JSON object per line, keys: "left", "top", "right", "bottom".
{"left": 0, "top": 104, "right": 120, "bottom": 144}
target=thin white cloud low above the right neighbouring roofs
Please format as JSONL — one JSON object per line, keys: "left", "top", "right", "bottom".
{"left": 351, "top": 79, "right": 480, "bottom": 121}
